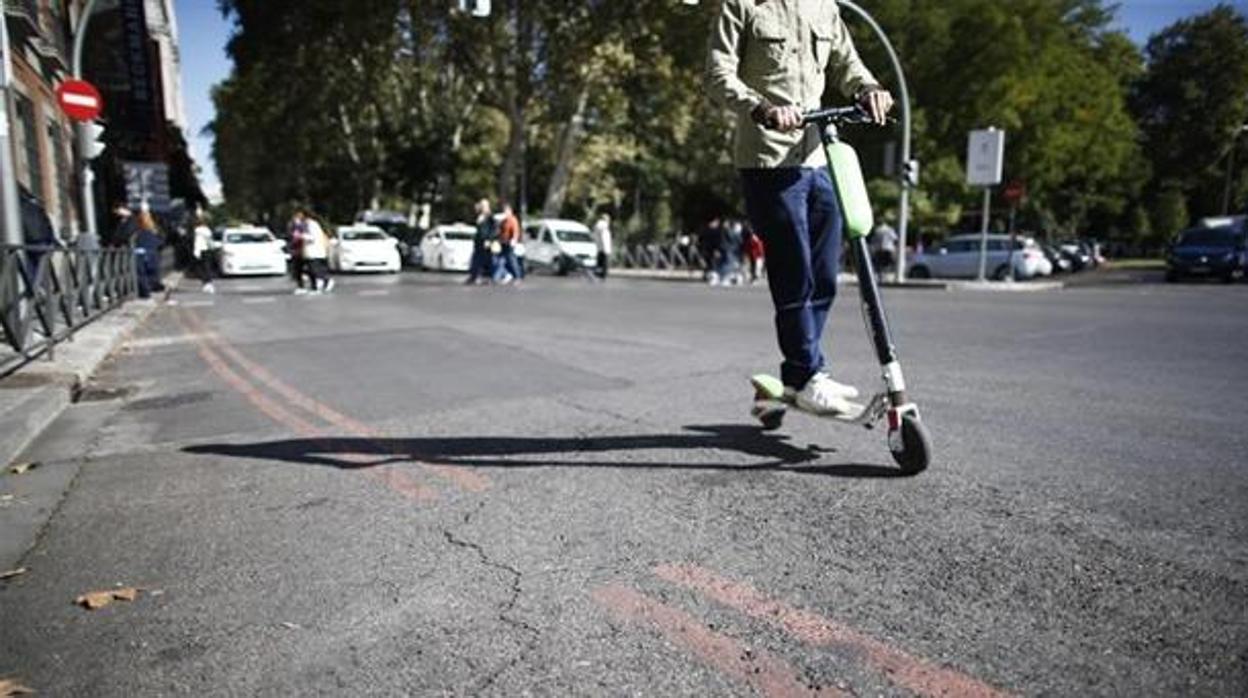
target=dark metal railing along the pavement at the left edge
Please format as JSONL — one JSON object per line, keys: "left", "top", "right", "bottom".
{"left": 0, "top": 245, "right": 139, "bottom": 375}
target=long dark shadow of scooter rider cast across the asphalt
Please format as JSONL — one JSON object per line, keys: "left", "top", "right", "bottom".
{"left": 182, "top": 425, "right": 906, "bottom": 478}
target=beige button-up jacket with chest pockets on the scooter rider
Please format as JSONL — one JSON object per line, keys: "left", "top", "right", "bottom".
{"left": 706, "top": 0, "right": 876, "bottom": 169}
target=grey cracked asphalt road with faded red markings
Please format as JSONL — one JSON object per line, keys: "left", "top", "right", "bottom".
{"left": 0, "top": 275, "right": 1248, "bottom": 696}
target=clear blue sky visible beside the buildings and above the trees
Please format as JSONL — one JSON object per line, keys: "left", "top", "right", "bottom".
{"left": 175, "top": 0, "right": 1248, "bottom": 199}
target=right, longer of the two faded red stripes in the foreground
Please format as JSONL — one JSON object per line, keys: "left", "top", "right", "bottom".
{"left": 654, "top": 564, "right": 1010, "bottom": 698}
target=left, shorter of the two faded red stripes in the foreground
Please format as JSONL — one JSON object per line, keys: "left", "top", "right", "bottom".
{"left": 593, "top": 584, "right": 844, "bottom": 697}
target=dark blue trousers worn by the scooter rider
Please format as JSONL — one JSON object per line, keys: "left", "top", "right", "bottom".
{"left": 741, "top": 167, "right": 844, "bottom": 390}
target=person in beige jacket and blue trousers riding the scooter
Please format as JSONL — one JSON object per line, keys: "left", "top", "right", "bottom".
{"left": 706, "top": 0, "right": 892, "bottom": 413}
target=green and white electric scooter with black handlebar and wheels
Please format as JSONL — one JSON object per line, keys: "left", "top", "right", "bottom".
{"left": 750, "top": 106, "right": 931, "bottom": 474}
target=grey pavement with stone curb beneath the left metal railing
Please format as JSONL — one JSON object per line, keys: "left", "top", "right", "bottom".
{"left": 0, "top": 272, "right": 182, "bottom": 466}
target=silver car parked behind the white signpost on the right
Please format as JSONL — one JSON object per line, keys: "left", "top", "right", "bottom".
{"left": 909, "top": 233, "right": 1051, "bottom": 280}
